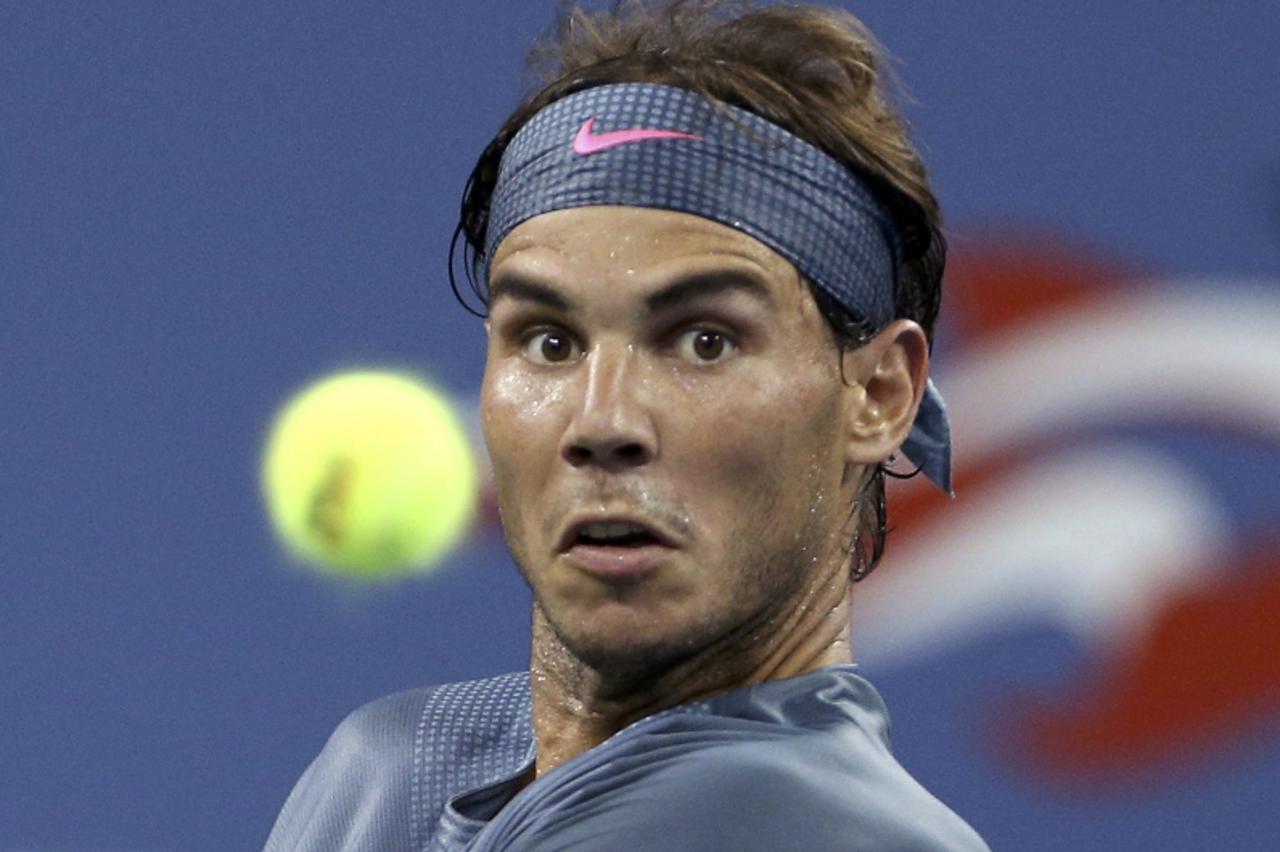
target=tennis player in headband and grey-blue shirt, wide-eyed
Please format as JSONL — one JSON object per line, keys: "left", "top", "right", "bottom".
{"left": 268, "top": 0, "right": 987, "bottom": 851}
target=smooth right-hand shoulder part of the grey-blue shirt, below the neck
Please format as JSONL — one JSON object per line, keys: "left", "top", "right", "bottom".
{"left": 484, "top": 673, "right": 987, "bottom": 852}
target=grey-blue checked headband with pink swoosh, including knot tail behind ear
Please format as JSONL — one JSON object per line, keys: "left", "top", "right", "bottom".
{"left": 484, "top": 83, "right": 951, "bottom": 494}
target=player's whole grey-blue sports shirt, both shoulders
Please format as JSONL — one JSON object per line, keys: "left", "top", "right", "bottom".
{"left": 266, "top": 665, "right": 987, "bottom": 852}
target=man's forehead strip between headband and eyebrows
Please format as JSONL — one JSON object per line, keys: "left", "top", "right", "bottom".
{"left": 489, "top": 206, "right": 799, "bottom": 285}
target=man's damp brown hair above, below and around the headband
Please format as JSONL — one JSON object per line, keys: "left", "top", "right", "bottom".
{"left": 449, "top": 0, "right": 946, "bottom": 580}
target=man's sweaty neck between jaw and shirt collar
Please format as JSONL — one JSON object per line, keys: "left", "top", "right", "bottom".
{"left": 530, "top": 562, "right": 854, "bottom": 777}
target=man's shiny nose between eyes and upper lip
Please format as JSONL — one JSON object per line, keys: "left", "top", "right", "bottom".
{"left": 561, "top": 344, "right": 658, "bottom": 472}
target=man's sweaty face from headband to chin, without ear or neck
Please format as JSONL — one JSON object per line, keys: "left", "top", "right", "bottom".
{"left": 481, "top": 207, "right": 850, "bottom": 668}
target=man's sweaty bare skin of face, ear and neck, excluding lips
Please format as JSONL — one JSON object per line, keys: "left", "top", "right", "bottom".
{"left": 481, "top": 207, "right": 928, "bottom": 775}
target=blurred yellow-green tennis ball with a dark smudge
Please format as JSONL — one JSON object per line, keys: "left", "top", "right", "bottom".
{"left": 262, "top": 371, "right": 479, "bottom": 580}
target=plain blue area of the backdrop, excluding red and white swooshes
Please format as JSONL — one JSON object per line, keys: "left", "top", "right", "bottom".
{"left": 0, "top": 0, "right": 1280, "bottom": 849}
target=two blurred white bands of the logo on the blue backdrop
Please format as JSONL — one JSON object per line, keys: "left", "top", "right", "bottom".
{"left": 854, "top": 279, "right": 1280, "bottom": 665}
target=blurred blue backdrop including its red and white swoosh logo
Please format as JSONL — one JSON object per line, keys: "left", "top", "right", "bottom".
{"left": 0, "top": 0, "right": 1280, "bottom": 849}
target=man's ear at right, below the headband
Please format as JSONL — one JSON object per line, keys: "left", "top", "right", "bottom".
{"left": 842, "top": 320, "right": 929, "bottom": 464}
